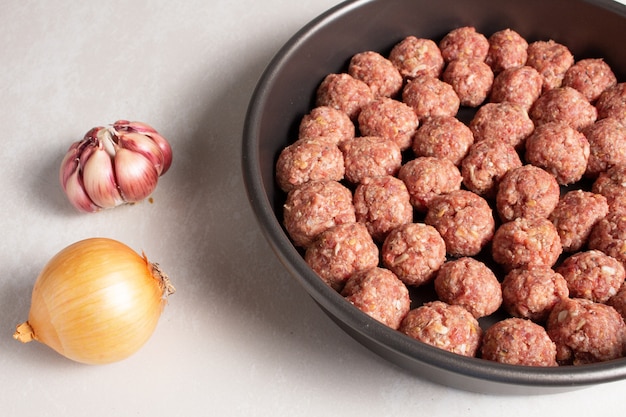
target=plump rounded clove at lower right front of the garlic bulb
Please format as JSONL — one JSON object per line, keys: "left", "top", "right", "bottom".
{"left": 115, "top": 148, "right": 159, "bottom": 203}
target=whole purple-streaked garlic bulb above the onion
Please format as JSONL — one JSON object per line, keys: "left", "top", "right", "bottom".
{"left": 59, "top": 120, "right": 172, "bottom": 212}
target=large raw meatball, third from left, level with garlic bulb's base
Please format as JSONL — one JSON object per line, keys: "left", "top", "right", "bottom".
{"left": 424, "top": 190, "right": 495, "bottom": 256}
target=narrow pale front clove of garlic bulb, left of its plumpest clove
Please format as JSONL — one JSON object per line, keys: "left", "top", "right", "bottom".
{"left": 81, "top": 145, "right": 124, "bottom": 208}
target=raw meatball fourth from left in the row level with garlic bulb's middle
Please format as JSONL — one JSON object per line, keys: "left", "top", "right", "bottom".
{"left": 461, "top": 139, "right": 522, "bottom": 198}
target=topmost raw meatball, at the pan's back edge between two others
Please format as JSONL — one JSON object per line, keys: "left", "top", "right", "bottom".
{"left": 439, "top": 26, "right": 489, "bottom": 62}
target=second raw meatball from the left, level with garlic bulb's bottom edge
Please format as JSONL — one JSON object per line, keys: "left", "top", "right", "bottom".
{"left": 354, "top": 175, "right": 413, "bottom": 241}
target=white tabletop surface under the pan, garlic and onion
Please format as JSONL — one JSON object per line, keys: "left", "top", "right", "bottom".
{"left": 0, "top": 0, "right": 626, "bottom": 417}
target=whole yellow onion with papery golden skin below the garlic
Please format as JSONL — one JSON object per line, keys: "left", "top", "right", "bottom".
{"left": 13, "top": 238, "right": 175, "bottom": 364}
